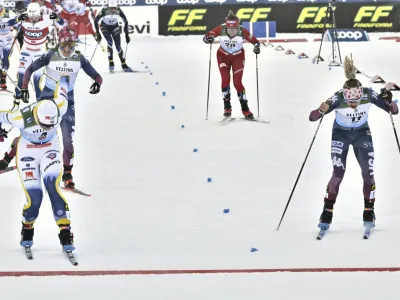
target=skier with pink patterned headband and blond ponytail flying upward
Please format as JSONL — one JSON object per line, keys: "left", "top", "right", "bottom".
{"left": 310, "top": 57, "right": 398, "bottom": 230}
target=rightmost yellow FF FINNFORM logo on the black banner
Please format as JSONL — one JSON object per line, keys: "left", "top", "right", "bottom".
{"left": 353, "top": 5, "right": 394, "bottom": 29}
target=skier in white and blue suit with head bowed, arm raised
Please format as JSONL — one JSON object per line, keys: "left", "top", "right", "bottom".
{"left": 0, "top": 76, "right": 75, "bottom": 251}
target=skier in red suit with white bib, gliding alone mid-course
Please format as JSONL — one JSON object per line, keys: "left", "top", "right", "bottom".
{"left": 203, "top": 11, "right": 260, "bottom": 119}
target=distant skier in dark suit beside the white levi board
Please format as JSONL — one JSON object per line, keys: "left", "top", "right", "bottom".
{"left": 94, "top": 0, "right": 132, "bottom": 72}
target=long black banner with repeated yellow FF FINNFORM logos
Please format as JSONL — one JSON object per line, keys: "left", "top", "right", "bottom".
{"left": 158, "top": 2, "right": 400, "bottom": 35}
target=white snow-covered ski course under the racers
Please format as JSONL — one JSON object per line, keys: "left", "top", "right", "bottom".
{"left": 0, "top": 35, "right": 400, "bottom": 300}
